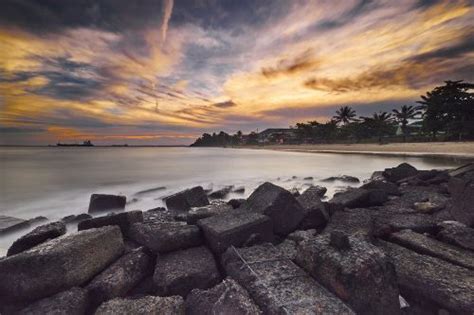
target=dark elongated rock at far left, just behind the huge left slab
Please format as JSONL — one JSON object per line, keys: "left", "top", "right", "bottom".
{"left": 7, "top": 221, "right": 66, "bottom": 256}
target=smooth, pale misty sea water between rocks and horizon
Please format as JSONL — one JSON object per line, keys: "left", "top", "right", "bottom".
{"left": 0, "top": 147, "right": 462, "bottom": 255}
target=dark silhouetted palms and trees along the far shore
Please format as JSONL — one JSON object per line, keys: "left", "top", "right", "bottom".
{"left": 193, "top": 80, "right": 474, "bottom": 146}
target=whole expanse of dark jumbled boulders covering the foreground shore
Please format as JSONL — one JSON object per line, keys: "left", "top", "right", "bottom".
{"left": 0, "top": 163, "right": 474, "bottom": 314}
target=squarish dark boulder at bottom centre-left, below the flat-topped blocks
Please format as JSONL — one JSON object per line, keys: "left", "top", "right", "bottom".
{"left": 153, "top": 246, "right": 221, "bottom": 297}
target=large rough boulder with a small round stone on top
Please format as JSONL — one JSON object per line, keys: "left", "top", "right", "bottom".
{"left": 295, "top": 231, "right": 400, "bottom": 314}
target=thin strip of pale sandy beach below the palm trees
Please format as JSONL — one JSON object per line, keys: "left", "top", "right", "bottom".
{"left": 244, "top": 142, "right": 474, "bottom": 159}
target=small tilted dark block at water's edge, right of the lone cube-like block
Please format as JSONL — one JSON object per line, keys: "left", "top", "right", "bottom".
{"left": 163, "top": 186, "right": 209, "bottom": 211}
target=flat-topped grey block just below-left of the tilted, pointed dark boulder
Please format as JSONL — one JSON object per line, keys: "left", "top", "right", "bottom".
{"left": 198, "top": 210, "right": 273, "bottom": 254}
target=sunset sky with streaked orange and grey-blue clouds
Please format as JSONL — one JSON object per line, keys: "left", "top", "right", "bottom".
{"left": 0, "top": 0, "right": 474, "bottom": 145}
